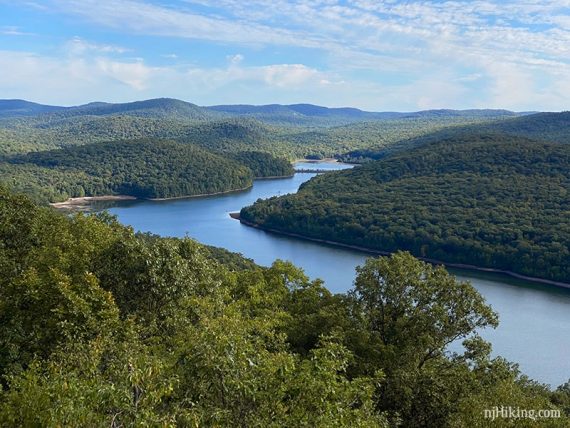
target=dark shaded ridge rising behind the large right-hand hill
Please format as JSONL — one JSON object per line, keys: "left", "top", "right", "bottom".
{"left": 339, "top": 112, "right": 570, "bottom": 162}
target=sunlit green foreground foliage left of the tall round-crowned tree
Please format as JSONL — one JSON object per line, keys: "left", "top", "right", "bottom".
{"left": 0, "top": 190, "right": 385, "bottom": 427}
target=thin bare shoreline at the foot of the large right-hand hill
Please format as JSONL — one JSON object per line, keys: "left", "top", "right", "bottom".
{"left": 230, "top": 212, "right": 570, "bottom": 290}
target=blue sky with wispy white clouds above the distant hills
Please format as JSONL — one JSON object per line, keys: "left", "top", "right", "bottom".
{"left": 0, "top": 0, "right": 570, "bottom": 111}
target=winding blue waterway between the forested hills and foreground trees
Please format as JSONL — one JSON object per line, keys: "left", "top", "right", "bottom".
{"left": 100, "top": 163, "right": 570, "bottom": 386}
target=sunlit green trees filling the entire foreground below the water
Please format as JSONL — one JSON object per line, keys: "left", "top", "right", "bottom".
{"left": 0, "top": 188, "right": 570, "bottom": 428}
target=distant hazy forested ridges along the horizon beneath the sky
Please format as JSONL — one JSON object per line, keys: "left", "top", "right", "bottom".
{"left": 0, "top": 99, "right": 516, "bottom": 160}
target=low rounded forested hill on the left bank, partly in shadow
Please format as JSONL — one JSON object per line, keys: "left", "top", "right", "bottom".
{"left": 0, "top": 140, "right": 253, "bottom": 202}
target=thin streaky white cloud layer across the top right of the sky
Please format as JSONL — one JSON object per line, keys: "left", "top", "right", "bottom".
{"left": 51, "top": 0, "right": 570, "bottom": 71}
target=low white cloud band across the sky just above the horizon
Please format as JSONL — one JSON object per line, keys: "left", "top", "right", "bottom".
{"left": 0, "top": 44, "right": 570, "bottom": 111}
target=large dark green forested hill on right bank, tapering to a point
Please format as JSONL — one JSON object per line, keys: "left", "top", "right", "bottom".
{"left": 241, "top": 134, "right": 570, "bottom": 283}
